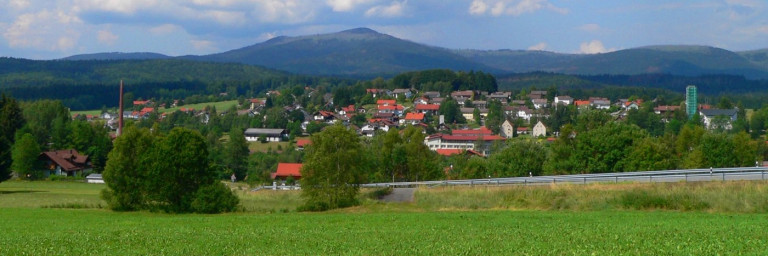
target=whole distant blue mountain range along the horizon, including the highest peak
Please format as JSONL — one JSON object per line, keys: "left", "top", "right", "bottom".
{"left": 64, "top": 28, "right": 768, "bottom": 79}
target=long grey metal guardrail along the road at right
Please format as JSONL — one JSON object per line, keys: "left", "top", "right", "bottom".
{"left": 360, "top": 167, "right": 768, "bottom": 187}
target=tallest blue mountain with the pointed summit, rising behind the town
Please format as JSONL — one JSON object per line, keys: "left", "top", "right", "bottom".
{"left": 186, "top": 28, "right": 494, "bottom": 77}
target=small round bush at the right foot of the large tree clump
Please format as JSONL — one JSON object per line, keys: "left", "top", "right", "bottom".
{"left": 192, "top": 182, "right": 240, "bottom": 213}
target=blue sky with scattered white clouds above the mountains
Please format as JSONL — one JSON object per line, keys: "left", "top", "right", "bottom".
{"left": 0, "top": 0, "right": 768, "bottom": 59}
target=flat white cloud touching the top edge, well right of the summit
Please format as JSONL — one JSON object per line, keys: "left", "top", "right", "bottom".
{"left": 469, "top": 0, "right": 569, "bottom": 16}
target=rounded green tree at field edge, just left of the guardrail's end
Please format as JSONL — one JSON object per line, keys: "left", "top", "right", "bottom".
{"left": 301, "top": 125, "right": 368, "bottom": 211}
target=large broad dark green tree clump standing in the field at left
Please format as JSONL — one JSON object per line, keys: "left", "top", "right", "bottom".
{"left": 102, "top": 128, "right": 237, "bottom": 213}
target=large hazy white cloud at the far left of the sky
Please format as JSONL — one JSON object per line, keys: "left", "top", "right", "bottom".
{"left": 3, "top": 10, "right": 82, "bottom": 51}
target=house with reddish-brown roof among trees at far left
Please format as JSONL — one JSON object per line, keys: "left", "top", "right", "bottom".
{"left": 38, "top": 149, "right": 92, "bottom": 176}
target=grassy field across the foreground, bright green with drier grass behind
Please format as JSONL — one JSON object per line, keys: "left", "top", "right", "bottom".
{"left": 0, "top": 181, "right": 768, "bottom": 255}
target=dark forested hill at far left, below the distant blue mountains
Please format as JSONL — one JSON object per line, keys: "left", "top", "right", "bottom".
{"left": 0, "top": 58, "right": 288, "bottom": 86}
